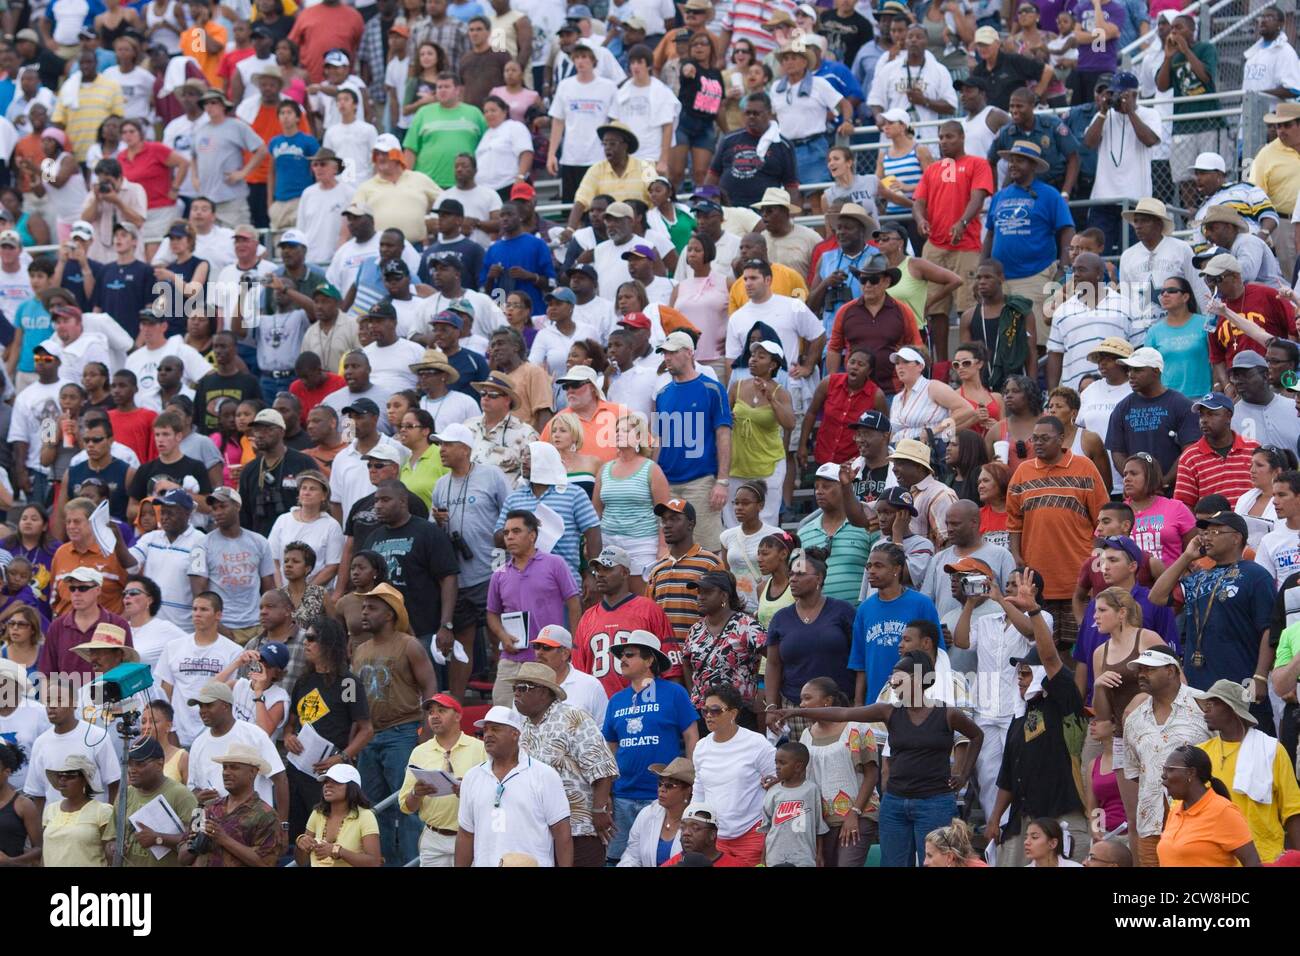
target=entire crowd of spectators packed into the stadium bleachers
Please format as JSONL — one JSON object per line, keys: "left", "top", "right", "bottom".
{"left": 0, "top": 0, "right": 1300, "bottom": 868}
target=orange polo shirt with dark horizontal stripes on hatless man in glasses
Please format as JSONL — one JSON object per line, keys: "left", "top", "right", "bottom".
{"left": 1006, "top": 450, "right": 1110, "bottom": 601}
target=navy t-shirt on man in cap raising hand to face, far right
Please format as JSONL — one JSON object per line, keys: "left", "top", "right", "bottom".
{"left": 1183, "top": 561, "right": 1277, "bottom": 691}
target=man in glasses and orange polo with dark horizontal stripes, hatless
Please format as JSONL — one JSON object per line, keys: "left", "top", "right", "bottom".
{"left": 1006, "top": 415, "right": 1110, "bottom": 645}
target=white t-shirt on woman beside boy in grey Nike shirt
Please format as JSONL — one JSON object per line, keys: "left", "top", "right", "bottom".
{"left": 692, "top": 727, "right": 776, "bottom": 840}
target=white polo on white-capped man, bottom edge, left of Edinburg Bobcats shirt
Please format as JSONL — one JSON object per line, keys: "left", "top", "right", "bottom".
{"left": 459, "top": 750, "right": 569, "bottom": 866}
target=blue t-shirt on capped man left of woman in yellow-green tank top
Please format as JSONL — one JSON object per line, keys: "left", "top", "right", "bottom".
{"left": 654, "top": 375, "right": 731, "bottom": 485}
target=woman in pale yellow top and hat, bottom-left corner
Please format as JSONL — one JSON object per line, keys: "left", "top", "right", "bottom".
{"left": 42, "top": 753, "right": 117, "bottom": 866}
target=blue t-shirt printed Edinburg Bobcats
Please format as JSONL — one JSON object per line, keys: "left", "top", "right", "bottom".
{"left": 605, "top": 678, "right": 699, "bottom": 800}
